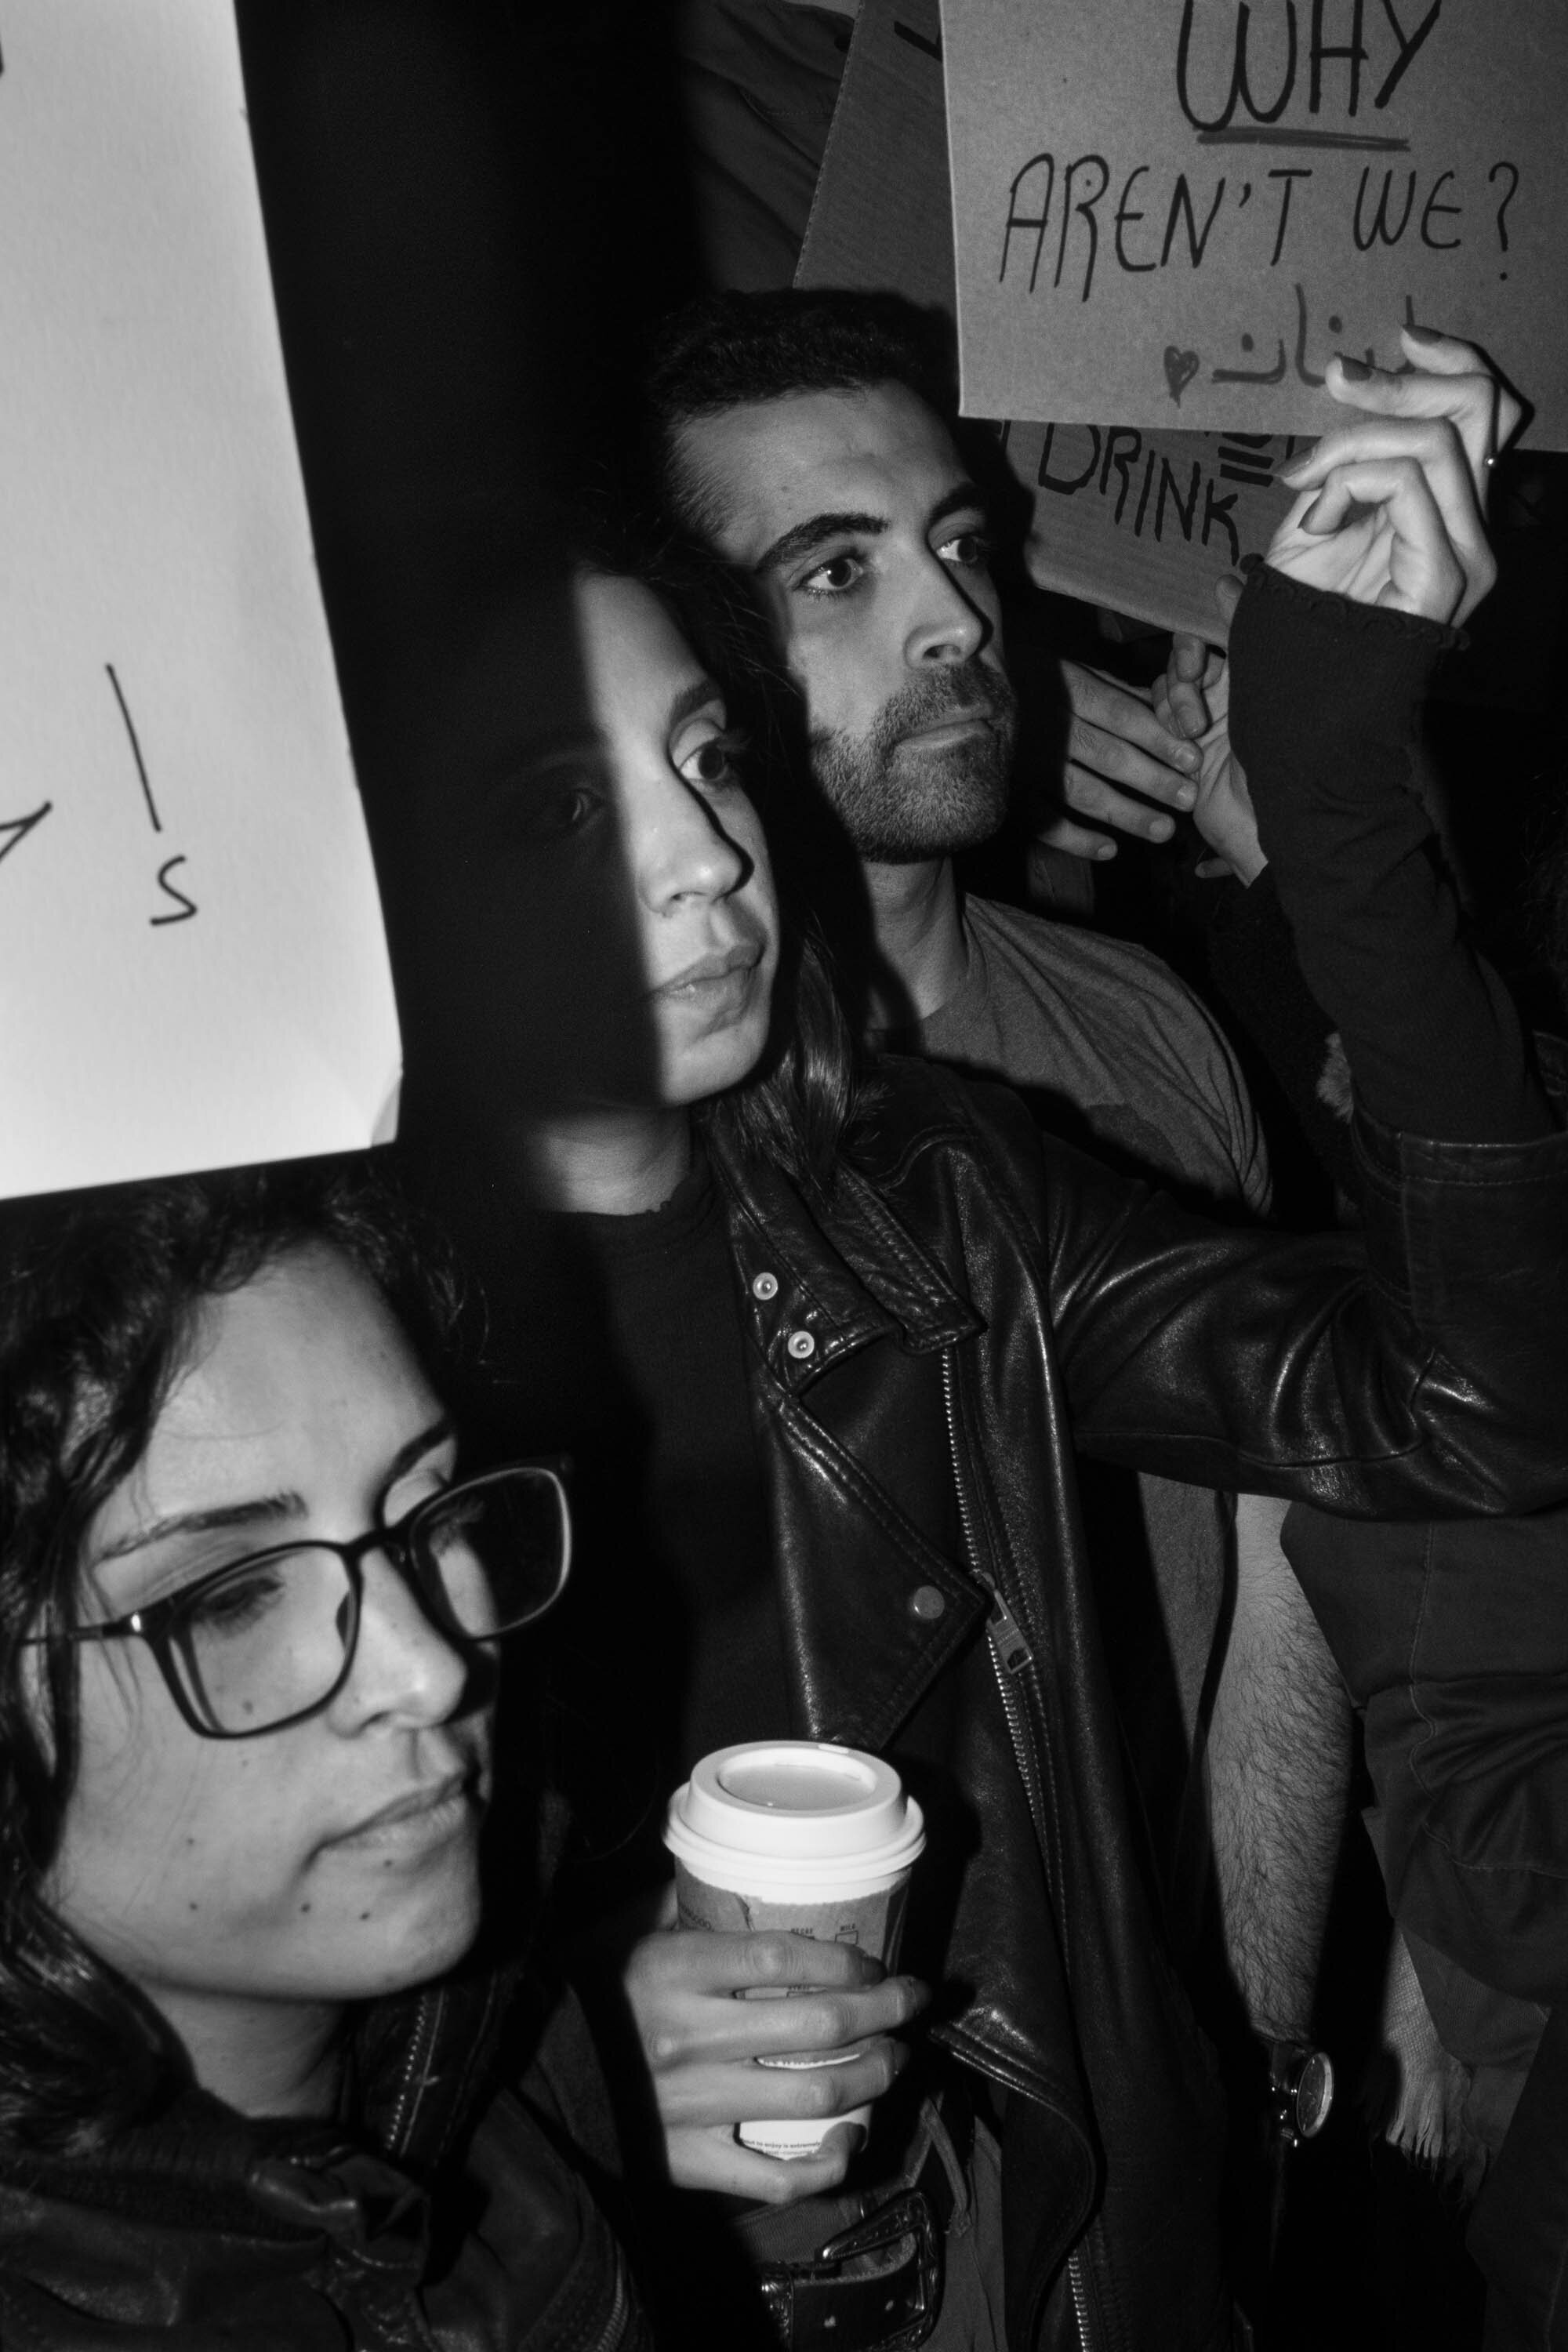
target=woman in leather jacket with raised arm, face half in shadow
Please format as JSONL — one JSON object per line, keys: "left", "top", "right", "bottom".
{"left": 392, "top": 343, "right": 1568, "bottom": 2352}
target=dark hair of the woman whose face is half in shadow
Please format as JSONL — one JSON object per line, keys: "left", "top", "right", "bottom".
{"left": 569, "top": 501, "right": 862, "bottom": 1192}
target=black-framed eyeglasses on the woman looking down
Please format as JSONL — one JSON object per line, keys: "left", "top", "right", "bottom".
{"left": 38, "top": 1463, "right": 572, "bottom": 1740}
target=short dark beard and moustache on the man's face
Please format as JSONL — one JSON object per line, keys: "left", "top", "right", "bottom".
{"left": 811, "top": 661, "right": 1018, "bottom": 866}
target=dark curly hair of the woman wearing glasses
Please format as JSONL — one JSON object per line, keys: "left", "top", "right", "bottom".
{"left": 0, "top": 1162, "right": 452, "bottom": 2152}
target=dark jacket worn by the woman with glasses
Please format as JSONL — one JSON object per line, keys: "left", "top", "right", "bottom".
{"left": 0, "top": 1983, "right": 652, "bottom": 2352}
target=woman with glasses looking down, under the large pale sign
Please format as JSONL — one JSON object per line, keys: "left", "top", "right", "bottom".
{"left": 0, "top": 1171, "right": 644, "bottom": 2352}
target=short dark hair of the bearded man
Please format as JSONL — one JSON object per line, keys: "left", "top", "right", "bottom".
{"left": 647, "top": 287, "right": 956, "bottom": 536}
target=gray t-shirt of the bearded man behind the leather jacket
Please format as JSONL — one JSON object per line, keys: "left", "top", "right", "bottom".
{"left": 898, "top": 898, "right": 1269, "bottom": 1835}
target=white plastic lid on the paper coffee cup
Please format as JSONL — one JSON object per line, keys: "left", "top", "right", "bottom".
{"left": 670, "top": 1740, "right": 924, "bottom": 1860}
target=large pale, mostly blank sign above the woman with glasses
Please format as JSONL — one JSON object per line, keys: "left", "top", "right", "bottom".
{"left": 0, "top": 0, "right": 397, "bottom": 1195}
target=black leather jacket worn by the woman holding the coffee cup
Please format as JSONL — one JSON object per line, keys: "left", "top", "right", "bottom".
{"left": 715, "top": 1063, "right": 1568, "bottom": 2352}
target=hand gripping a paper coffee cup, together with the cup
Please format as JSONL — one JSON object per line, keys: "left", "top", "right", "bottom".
{"left": 626, "top": 1740, "right": 926, "bottom": 2204}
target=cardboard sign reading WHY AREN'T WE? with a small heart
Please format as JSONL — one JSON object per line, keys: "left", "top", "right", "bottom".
{"left": 942, "top": 0, "right": 1568, "bottom": 449}
